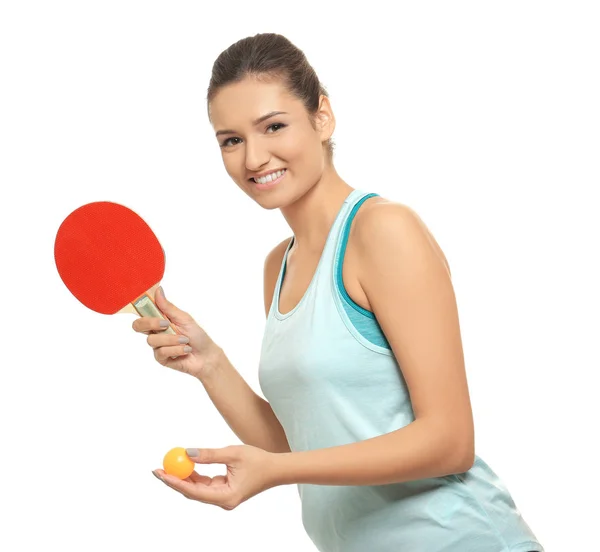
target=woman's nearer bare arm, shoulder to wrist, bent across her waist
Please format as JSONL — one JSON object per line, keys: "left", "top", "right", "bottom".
{"left": 271, "top": 203, "right": 475, "bottom": 485}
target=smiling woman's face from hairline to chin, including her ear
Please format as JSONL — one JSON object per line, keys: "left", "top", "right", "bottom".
{"left": 210, "top": 78, "right": 334, "bottom": 209}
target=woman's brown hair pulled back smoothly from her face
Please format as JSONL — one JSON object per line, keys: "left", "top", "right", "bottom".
{"left": 206, "top": 33, "right": 335, "bottom": 159}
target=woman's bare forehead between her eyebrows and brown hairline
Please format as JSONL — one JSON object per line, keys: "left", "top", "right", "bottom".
{"left": 210, "top": 77, "right": 303, "bottom": 130}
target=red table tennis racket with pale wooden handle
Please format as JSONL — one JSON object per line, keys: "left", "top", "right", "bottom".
{"left": 54, "top": 201, "right": 176, "bottom": 334}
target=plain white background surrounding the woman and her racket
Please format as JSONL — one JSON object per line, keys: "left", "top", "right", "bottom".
{"left": 0, "top": 0, "right": 600, "bottom": 552}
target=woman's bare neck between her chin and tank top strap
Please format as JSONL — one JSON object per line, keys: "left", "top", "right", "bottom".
{"left": 281, "top": 165, "right": 353, "bottom": 254}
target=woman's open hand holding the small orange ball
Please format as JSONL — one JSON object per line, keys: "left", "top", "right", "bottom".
{"left": 152, "top": 445, "right": 277, "bottom": 510}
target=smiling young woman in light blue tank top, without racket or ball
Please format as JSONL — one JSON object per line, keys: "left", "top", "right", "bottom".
{"left": 133, "top": 34, "right": 543, "bottom": 552}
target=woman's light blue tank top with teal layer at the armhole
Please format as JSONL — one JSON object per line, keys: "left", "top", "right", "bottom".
{"left": 259, "top": 190, "right": 544, "bottom": 552}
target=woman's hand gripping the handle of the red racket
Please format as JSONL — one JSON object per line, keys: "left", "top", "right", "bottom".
{"left": 132, "top": 288, "right": 220, "bottom": 378}
